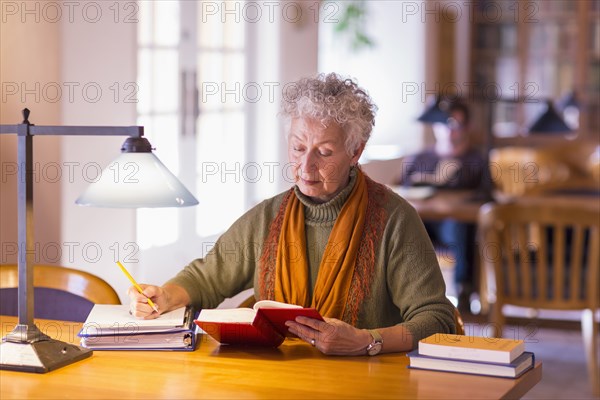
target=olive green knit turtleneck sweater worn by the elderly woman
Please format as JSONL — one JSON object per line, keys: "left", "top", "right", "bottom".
{"left": 169, "top": 170, "right": 455, "bottom": 346}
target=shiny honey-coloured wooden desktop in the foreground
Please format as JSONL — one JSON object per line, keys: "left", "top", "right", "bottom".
{"left": 0, "top": 317, "right": 542, "bottom": 400}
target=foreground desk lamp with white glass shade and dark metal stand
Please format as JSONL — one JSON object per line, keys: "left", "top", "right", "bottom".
{"left": 0, "top": 109, "right": 198, "bottom": 373}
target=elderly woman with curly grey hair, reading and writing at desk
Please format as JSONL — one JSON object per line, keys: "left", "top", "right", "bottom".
{"left": 129, "top": 74, "right": 455, "bottom": 355}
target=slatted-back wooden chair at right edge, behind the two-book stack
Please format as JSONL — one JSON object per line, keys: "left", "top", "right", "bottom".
{"left": 479, "top": 202, "right": 600, "bottom": 395}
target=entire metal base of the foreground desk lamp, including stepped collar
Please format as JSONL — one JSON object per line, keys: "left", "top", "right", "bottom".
{"left": 0, "top": 324, "right": 92, "bottom": 373}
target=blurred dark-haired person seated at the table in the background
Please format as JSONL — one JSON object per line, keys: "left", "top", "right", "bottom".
{"left": 398, "top": 102, "right": 489, "bottom": 311}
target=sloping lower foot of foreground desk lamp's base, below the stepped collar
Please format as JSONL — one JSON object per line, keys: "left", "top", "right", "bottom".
{"left": 0, "top": 339, "right": 93, "bottom": 373}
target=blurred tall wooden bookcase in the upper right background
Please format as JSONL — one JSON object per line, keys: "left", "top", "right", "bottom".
{"left": 470, "top": 0, "right": 600, "bottom": 145}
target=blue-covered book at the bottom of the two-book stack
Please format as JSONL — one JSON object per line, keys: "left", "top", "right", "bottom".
{"left": 407, "top": 350, "right": 535, "bottom": 378}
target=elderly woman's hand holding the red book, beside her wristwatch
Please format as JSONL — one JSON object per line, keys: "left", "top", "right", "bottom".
{"left": 285, "top": 317, "right": 373, "bottom": 356}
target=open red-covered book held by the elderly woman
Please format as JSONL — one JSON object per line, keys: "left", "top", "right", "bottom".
{"left": 194, "top": 300, "right": 323, "bottom": 347}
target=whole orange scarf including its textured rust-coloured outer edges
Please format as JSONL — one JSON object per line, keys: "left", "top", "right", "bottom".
{"left": 257, "top": 169, "right": 389, "bottom": 326}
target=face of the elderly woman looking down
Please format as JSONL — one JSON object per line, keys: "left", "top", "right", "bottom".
{"left": 288, "top": 118, "right": 364, "bottom": 203}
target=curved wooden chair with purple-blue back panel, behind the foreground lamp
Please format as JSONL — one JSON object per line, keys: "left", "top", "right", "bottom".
{"left": 0, "top": 264, "right": 121, "bottom": 322}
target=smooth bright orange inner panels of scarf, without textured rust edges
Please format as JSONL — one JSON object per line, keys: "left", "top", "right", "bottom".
{"left": 274, "top": 171, "right": 368, "bottom": 319}
